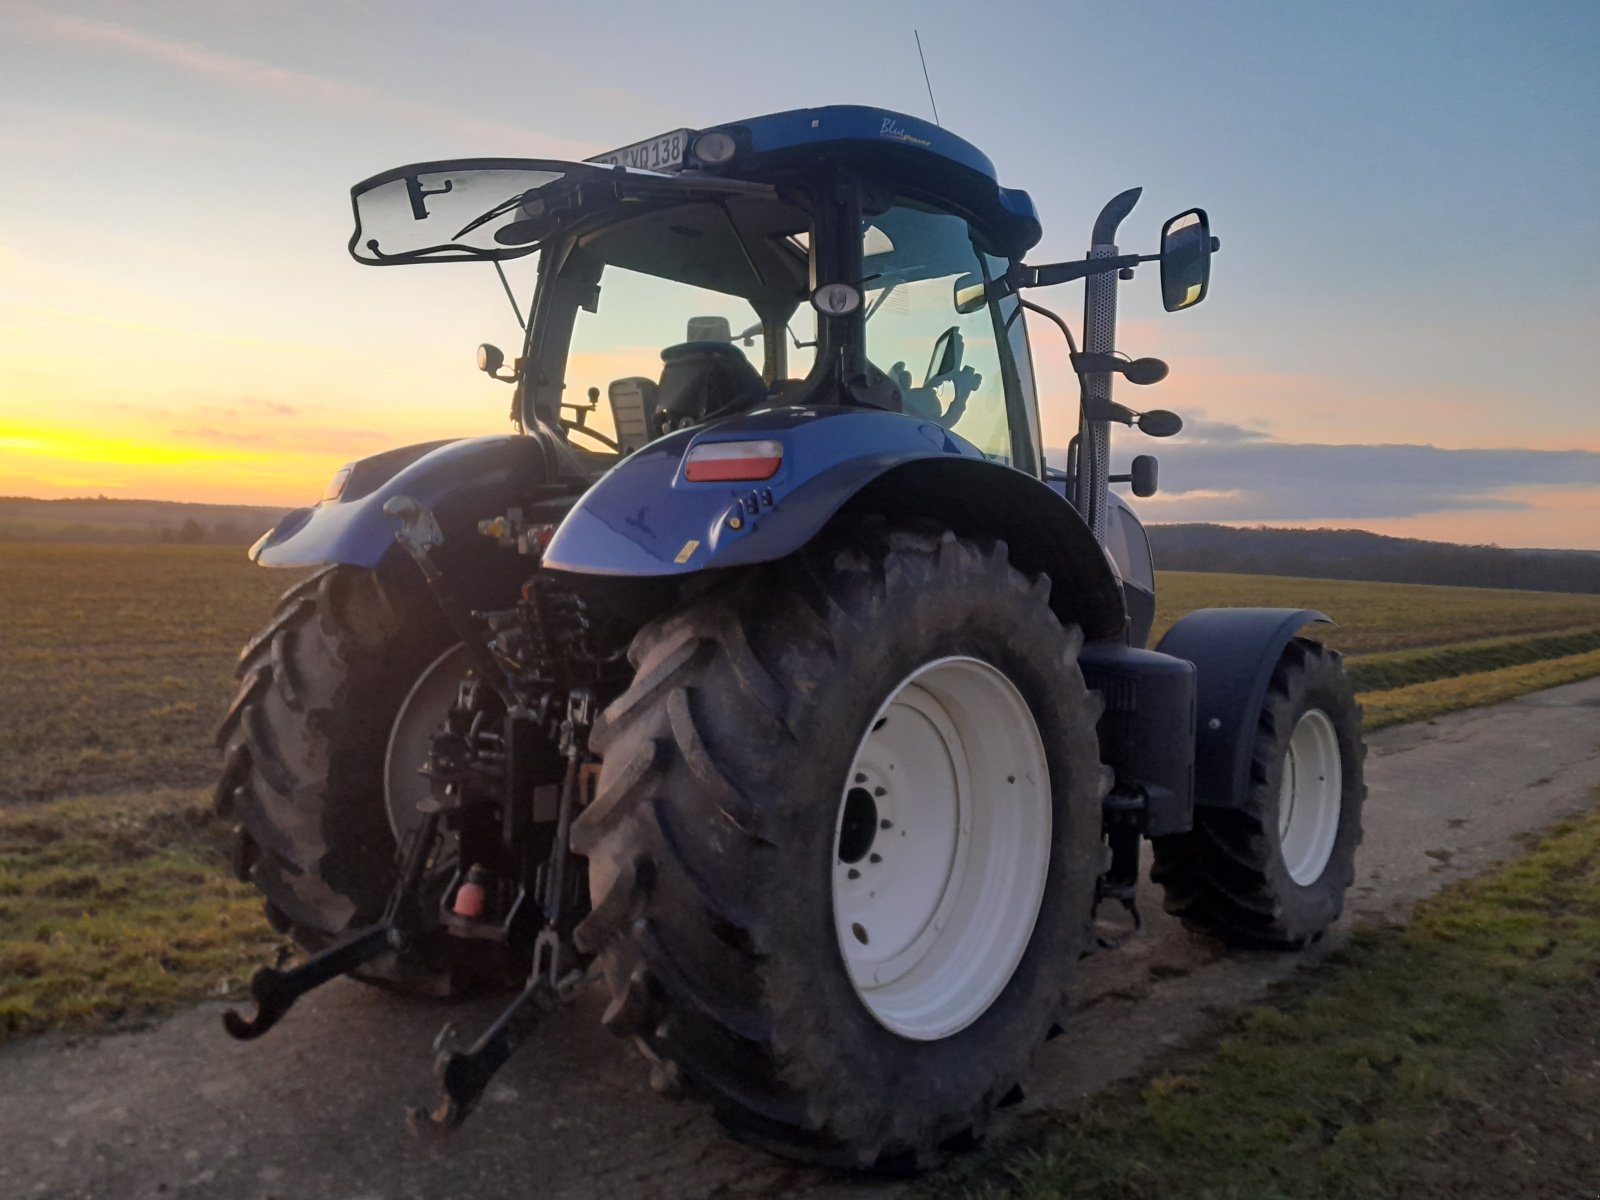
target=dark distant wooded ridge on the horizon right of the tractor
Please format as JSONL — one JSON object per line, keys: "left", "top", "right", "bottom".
{"left": 1149, "top": 525, "right": 1600, "bottom": 592}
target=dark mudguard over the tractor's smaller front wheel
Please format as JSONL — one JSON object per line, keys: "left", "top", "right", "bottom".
{"left": 1157, "top": 608, "right": 1333, "bottom": 808}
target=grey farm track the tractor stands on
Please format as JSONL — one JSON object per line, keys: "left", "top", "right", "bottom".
{"left": 9, "top": 678, "right": 1600, "bottom": 1200}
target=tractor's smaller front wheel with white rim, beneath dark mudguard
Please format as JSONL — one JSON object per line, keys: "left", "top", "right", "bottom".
{"left": 1150, "top": 637, "right": 1366, "bottom": 950}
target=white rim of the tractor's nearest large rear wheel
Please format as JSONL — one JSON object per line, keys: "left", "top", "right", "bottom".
{"left": 834, "top": 658, "right": 1051, "bottom": 1042}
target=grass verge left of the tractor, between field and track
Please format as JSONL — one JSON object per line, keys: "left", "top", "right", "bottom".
{"left": 0, "top": 790, "right": 278, "bottom": 1038}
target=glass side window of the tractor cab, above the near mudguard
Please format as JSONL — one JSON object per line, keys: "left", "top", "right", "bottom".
{"left": 861, "top": 203, "right": 1014, "bottom": 464}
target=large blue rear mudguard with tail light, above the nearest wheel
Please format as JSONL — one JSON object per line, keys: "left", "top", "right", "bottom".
{"left": 544, "top": 408, "right": 1125, "bottom": 637}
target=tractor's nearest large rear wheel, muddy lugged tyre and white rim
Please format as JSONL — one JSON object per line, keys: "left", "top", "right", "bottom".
{"left": 573, "top": 528, "right": 1104, "bottom": 1170}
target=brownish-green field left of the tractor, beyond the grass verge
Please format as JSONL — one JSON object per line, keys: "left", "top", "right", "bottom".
{"left": 0, "top": 546, "right": 301, "bottom": 805}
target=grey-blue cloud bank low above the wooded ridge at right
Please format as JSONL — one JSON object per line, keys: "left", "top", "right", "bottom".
{"left": 1056, "top": 438, "right": 1600, "bottom": 522}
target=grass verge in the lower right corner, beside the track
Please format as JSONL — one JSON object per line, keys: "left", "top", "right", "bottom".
{"left": 925, "top": 800, "right": 1600, "bottom": 1200}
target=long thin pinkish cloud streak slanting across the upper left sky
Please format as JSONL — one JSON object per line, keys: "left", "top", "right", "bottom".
{"left": 9, "top": 8, "right": 592, "bottom": 157}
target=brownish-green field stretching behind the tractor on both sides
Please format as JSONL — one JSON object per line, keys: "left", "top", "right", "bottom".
{"left": 0, "top": 546, "right": 1600, "bottom": 805}
